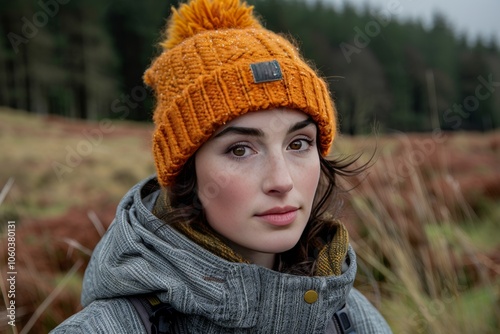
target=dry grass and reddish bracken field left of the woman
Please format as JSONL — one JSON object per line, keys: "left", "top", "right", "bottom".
{"left": 0, "top": 109, "right": 154, "bottom": 333}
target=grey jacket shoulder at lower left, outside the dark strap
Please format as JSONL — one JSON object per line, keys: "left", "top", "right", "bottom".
{"left": 50, "top": 298, "right": 146, "bottom": 334}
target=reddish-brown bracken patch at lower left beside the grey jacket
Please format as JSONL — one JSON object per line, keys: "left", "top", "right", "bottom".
{"left": 0, "top": 206, "right": 115, "bottom": 333}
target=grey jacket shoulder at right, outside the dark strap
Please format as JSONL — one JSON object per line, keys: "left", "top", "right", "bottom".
{"left": 347, "top": 288, "right": 392, "bottom": 334}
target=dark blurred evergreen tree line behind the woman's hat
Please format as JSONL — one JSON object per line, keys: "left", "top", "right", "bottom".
{"left": 0, "top": 0, "right": 500, "bottom": 134}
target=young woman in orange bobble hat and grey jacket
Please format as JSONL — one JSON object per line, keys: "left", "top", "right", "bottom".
{"left": 54, "top": 0, "right": 390, "bottom": 334}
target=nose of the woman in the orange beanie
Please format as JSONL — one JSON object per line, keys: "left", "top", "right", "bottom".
{"left": 263, "top": 154, "right": 293, "bottom": 195}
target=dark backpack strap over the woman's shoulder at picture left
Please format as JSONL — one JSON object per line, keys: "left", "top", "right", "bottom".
{"left": 129, "top": 295, "right": 175, "bottom": 334}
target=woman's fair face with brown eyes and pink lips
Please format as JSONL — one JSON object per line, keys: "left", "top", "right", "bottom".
{"left": 195, "top": 109, "right": 320, "bottom": 267}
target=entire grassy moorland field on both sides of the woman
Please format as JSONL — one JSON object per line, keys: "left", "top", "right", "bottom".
{"left": 0, "top": 109, "right": 500, "bottom": 333}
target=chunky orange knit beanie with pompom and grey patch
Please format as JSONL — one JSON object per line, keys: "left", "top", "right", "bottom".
{"left": 144, "top": 0, "right": 336, "bottom": 186}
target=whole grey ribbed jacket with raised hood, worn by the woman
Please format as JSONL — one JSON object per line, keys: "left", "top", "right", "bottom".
{"left": 52, "top": 177, "right": 390, "bottom": 334}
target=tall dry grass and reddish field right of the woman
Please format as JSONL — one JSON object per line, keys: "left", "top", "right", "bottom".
{"left": 332, "top": 134, "right": 500, "bottom": 333}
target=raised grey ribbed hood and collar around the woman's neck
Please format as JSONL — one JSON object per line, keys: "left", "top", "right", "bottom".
{"left": 82, "top": 176, "right": 356, "bottom": 328}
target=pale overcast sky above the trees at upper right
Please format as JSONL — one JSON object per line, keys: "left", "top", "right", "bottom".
{"left": 322, "top": 0, "right": 500, "bottom": 42}
